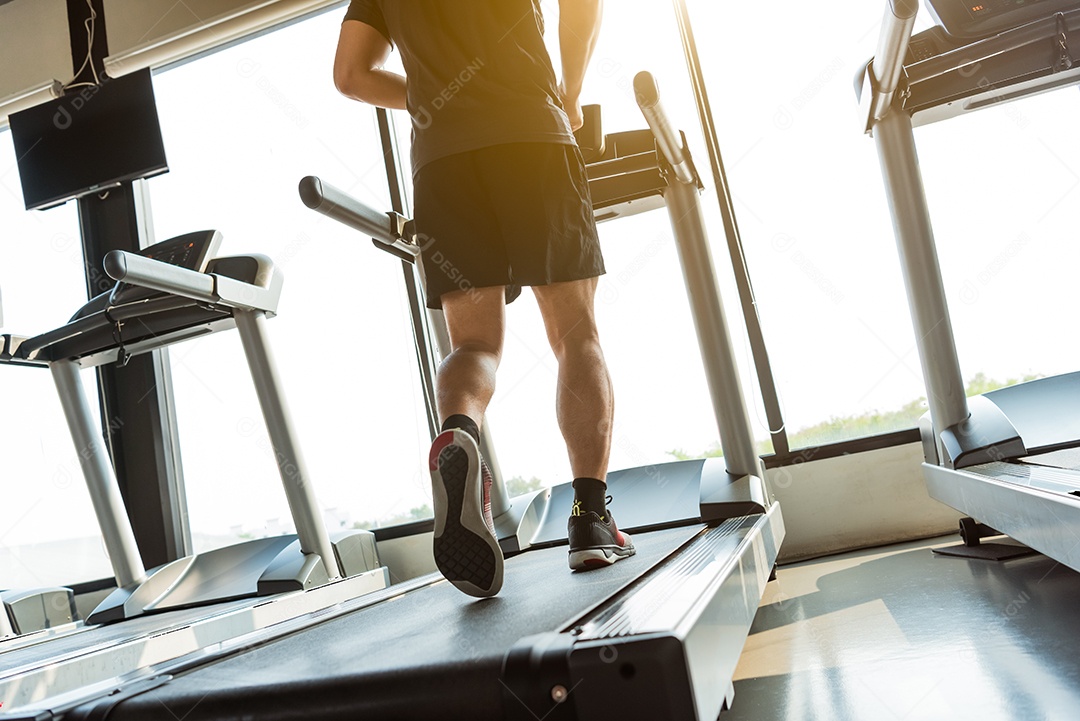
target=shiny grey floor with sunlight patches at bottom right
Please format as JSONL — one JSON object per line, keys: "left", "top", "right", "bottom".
{"left": 720, "top": 536, "right": 1080, "bottom": 721}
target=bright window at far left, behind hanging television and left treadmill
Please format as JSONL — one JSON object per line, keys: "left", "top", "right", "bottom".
{"left": 0, "top": 132, "right": 111, "bottom": 588}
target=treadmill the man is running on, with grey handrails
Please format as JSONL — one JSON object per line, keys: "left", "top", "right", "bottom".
{"left": 4, "top": 74, "right": 784, "bottom": 721}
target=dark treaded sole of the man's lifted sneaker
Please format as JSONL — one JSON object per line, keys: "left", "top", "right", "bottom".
{"left": 432, "top": 433, "right": 502, "bottom": 598}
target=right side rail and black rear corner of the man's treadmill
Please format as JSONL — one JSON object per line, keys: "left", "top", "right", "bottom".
{"left": 503, "top": 503, "right": 784, "bottom": 721}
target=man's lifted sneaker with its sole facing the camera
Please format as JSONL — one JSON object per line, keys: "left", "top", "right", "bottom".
{"left": 428, "top": 428, "right": 502, "bottom": 598}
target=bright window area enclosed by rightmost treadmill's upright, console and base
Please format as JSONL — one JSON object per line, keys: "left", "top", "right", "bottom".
{"left": 915, "top": 87, "right": 1080, "bottom": 388}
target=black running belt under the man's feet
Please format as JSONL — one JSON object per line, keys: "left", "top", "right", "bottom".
{"left": 67, "top": 525, "right": 702, "bottom": 721}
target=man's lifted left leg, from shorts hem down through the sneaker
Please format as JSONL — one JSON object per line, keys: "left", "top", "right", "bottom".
{"left": 429, "top": 286, "right": 505, "bottom": 597}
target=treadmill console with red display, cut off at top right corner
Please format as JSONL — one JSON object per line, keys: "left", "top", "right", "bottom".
{"left": 927, "top": 0, "right": 1080, "bottom": 40}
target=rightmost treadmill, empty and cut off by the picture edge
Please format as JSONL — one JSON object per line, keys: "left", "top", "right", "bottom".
{"left": 855, "top": 0, "right": 1080, "bottom": 570}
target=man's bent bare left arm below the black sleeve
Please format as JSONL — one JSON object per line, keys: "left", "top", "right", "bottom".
{"left": 334, "top": 21, "right": 405, "bottom": 110}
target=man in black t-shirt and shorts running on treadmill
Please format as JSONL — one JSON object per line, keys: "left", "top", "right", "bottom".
{"left": 334, "top": 0, "right": 634, "bottom": 597}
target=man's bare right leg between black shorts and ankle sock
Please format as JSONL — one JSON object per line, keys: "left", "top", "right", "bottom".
{"left": 532, "top": 277, "right": 615, "bottom": 481}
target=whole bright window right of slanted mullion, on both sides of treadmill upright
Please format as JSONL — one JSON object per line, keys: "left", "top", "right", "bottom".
{"left": 690, "top": 0, "right": 1080, "bottom": 447}
